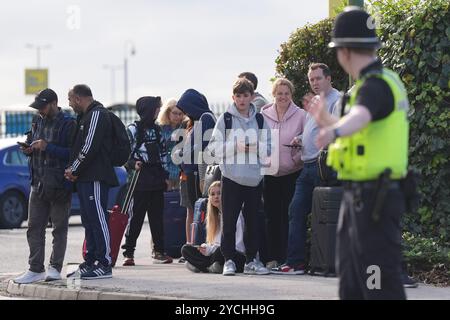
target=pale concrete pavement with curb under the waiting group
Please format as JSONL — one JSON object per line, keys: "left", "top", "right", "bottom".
{"left": 3, "top": 259, "right": 450, "bottom": 300}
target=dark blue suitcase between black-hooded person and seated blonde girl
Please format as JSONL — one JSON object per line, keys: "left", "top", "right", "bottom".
{"left": 163, "top": 190, "right": 186, "bottom": 258}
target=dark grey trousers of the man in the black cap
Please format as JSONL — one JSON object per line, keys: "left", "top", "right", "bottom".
{"left": 27, "top": 187, "right": 72, "bottom": 272}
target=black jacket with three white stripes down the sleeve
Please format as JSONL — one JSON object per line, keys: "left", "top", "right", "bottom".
{"left": 69, "top": 101, "right": 119, "bottom": 187}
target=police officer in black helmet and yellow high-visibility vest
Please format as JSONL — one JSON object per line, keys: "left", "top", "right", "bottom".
{"left": 308, "top": 7, "right": 409, "bottom": 299}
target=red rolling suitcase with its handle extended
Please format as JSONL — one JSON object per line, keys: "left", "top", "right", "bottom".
{"left": 83, "top": 171, "right": 140, "bottom": 267}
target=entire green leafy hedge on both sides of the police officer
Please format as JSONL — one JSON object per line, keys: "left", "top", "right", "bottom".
{"left": 276, "top": 0, "right": 450, "bottom": 245}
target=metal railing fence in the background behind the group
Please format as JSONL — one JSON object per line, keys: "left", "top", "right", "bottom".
{"left": 0, "top": 103, "right": 229, "bottom": 138}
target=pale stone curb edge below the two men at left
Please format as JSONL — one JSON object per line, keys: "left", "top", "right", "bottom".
{"left": 6, "top": 280, "right": 178, "bottom": 300}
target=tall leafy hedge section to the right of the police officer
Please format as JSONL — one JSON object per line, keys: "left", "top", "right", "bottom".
{"left": 371, "top": 0, "right": 450, "bottom": 243}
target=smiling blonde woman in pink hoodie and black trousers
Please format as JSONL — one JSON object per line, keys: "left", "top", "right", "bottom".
{"left": 261, "top": 78, "right": 306, "bottom": 268}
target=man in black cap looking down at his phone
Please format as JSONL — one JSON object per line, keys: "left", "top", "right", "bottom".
{"left": 14, "top": 89, "right": 75, "bottom": 283}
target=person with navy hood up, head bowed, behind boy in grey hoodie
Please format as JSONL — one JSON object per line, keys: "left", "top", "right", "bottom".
{"left": 177, "top": 89, "right": 216, "bottom": 242}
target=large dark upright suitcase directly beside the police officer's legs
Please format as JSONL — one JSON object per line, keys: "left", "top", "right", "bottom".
{"left": 309, "top": 187, "right": 342, "bottom": 276}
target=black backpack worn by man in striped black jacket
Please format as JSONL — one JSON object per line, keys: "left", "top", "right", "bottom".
{"left": 108, "top": 111, "right": 131, "bottom": 167}
